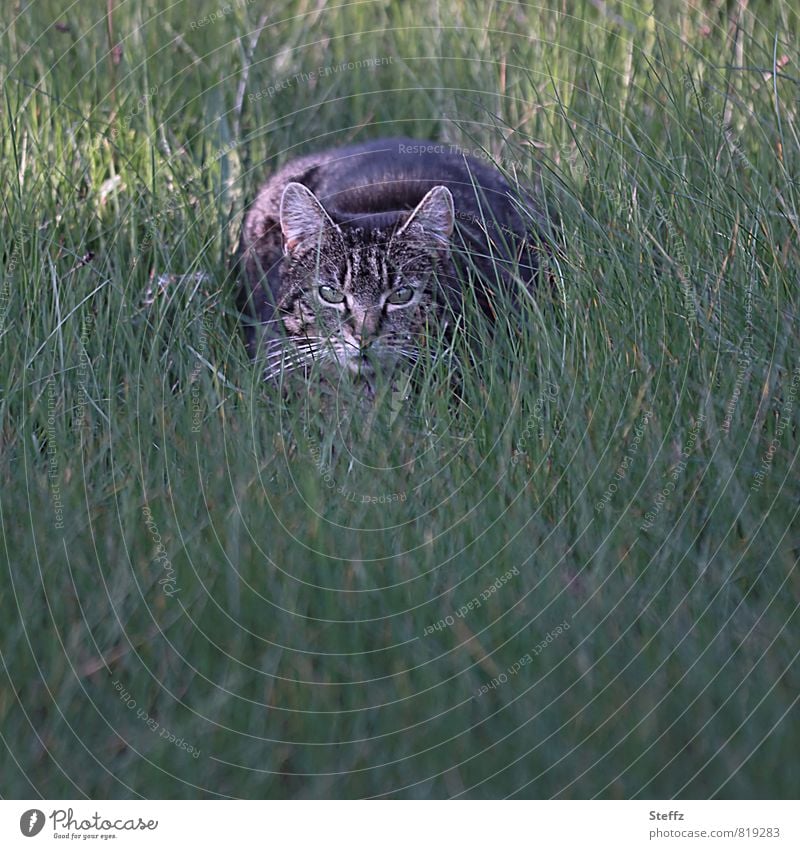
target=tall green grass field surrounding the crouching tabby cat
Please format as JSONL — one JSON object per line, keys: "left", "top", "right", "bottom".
{"left": 0, "top": 0, "right": 800, "bottom": 798}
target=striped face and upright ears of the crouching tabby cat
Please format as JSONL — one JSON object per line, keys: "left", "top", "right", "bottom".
{"left": 275, "top": 183, "right": 454, "bottom": 376}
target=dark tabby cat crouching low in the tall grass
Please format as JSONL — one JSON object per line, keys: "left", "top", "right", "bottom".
{"left": 234, "top": 138, "right": 546, "bottom": 379}
